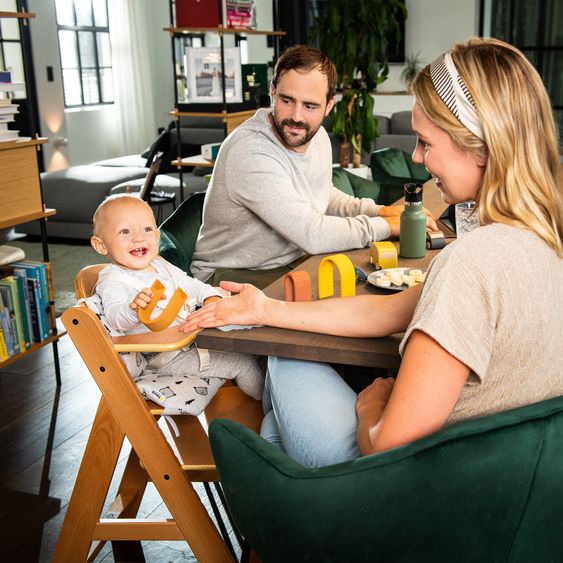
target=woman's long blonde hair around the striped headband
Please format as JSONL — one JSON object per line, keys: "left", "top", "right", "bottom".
{"left": 413, "top": 37, "right": 563, "bottom": 257}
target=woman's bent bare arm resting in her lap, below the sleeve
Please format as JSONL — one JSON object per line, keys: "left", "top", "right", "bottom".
{"left": 356, "top": 330, "right": 469, "bottom": 455}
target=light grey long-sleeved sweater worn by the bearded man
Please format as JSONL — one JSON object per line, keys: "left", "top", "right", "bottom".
{"left": 191, "top": 109, "right": 389, "bottom": 280}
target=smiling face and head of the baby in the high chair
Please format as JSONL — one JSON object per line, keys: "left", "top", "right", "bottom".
{"left": 92, "top": 200, "right": 160, "bottom": 270}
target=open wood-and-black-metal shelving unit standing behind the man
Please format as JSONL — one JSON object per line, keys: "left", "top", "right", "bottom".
{"left": 164, "top": 0, "right": 286, "bottom": 189}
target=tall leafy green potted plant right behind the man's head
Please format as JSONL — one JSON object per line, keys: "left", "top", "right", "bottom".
{"left": 311, "top": 0, "right": 407, "bottom": 168}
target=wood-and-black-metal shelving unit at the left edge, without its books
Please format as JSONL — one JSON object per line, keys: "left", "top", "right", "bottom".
{"left": 0, "top": 10, "right": 62, "bottom": 386}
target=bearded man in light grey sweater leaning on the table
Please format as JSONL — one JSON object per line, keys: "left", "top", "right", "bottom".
{"left": 191, "top": 45, "right": 435, "bottom": 288}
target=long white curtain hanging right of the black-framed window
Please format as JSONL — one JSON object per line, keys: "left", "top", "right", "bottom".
{"left": 108, "top": 0, "right": 157, "bottom": 155}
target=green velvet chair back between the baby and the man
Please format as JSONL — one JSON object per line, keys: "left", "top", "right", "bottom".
{"left": 158, "top": 192, "right": 205, "bottom": 276}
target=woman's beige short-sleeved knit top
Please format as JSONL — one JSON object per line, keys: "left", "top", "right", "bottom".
{"left": 400, "top": 224, "right": 563, "bottom": 424}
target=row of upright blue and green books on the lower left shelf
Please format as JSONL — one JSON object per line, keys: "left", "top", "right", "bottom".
{"left": 0, "top": 260, "right": 55, "bottom": 362}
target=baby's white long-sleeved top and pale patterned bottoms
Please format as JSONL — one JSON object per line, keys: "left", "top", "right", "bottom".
{"left": 84, "top": 257, "right": 264, "bottom": 415}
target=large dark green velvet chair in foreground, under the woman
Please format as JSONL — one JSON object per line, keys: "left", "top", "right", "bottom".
{"left": 210, "top": 397, "right": 563, "bottom": 563}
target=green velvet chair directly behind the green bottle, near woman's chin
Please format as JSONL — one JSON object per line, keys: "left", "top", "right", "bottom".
{"left": 370, "top": 148, "right": 430, "bottom": 205}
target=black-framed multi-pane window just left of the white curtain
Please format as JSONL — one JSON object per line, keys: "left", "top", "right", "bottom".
{"left": 56, "top": 0, "right": 113, "bottom": 107}
